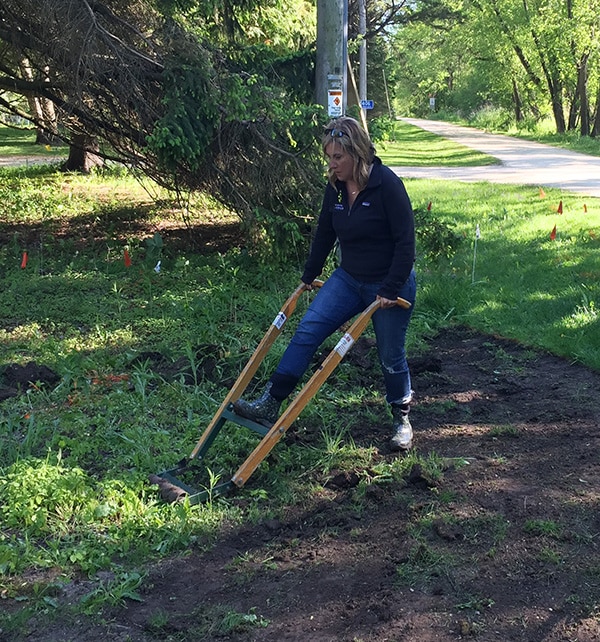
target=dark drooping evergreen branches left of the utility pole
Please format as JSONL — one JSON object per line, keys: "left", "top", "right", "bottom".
{"left": 0, "top": 0, "right": 323, "bottom": 238}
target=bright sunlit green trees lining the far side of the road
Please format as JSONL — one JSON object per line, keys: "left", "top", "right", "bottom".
{"left": 393, "top": 0, "right": 600, "bottom": 136}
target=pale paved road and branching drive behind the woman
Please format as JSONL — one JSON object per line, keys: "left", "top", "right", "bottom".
{"left": 394, "top": 118, "right": 600, "bottom": 198}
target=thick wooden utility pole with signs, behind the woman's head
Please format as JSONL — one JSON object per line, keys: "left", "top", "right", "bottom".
{"left": 315, "top": 0, "right": 348, "bottom": 118}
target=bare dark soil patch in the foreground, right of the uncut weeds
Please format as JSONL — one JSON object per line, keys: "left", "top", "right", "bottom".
{"left": 14, "top": 328, "right": 600, "bottom": 642}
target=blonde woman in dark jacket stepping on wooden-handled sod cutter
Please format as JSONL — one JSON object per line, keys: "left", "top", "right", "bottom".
{"left": 234, "top": 116, "right": 416, "bottom": 450}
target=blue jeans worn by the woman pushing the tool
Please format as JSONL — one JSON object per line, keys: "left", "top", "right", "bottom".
{"left": 270, "top": 268, "right": 416, "bottom": 405}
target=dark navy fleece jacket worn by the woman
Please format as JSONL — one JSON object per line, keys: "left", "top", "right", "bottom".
{"left": 302, "top": 157, "right": 415, "bottom": 299}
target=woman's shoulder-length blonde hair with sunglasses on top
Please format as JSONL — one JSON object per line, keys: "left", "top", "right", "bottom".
{"left": 321, "top": 116, "right": 375, "bottom": 190}
